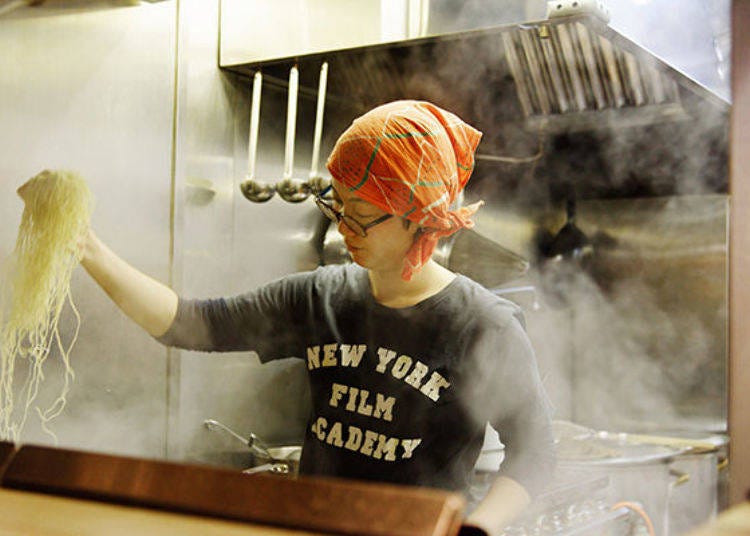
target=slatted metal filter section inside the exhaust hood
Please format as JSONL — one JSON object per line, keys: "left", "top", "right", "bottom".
{"left": 502, "top": 17, "right": 722, "bottom": 130}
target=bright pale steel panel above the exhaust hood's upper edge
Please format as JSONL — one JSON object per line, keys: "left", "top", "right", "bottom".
{"left": 220, "top": 0, "right": 545, "bottom": 66}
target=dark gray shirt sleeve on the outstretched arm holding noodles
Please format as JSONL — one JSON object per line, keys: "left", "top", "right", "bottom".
{"left": 157, "top": 273, "right": 313, "bottom": 362}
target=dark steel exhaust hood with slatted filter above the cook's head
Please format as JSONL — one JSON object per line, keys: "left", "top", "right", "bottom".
{"left": 222, "top": 14, "right": 730, "bottom": 204}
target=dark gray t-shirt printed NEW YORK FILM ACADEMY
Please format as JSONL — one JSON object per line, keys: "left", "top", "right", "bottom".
{"left": 159, "top": 264, "right": 553, "bottom": 495}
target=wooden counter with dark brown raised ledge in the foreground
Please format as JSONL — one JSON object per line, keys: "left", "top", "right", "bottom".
{"left": 0, "top": 446, "right": 464, "bottom": 536}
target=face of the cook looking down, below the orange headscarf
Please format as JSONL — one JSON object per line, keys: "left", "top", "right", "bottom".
{"left": 332, "top": 180, "right": 418, "bottom": 273}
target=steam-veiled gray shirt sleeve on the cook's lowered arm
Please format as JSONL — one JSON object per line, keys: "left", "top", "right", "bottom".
{"left": 464, "top": 310, "right": 555, "bottom": 497}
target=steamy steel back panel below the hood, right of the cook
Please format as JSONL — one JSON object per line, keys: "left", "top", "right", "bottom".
{"left": 470, "top": 195, "right": 728, "bottom": 430}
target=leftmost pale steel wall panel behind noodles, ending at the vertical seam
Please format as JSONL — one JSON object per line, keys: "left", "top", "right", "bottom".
{"left": 0, "top": 2, "right": 176, "bottom": 456}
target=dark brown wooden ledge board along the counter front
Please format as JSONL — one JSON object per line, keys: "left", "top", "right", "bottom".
{"left": 2, "top": 446, "right": 463, "bottom": 536}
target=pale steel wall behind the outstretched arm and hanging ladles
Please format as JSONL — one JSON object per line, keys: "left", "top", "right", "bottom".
{"left": 0, "top": 0, "right": 346, "bottom": 461}
